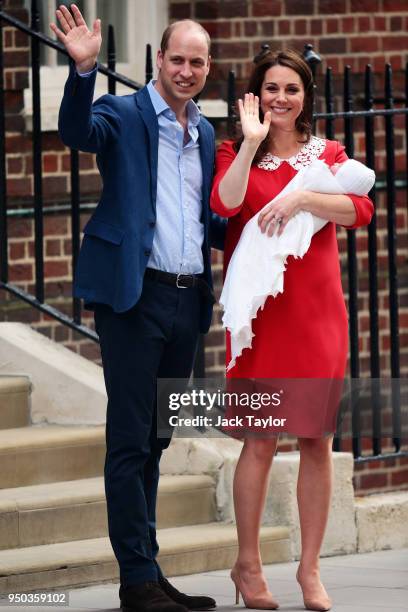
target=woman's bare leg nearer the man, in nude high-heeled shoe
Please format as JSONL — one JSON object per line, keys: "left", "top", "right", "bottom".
{"left": 231, "top": 437, "right": 278, "bottom": 604}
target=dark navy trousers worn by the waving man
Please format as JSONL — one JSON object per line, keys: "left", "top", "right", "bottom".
{"left": 94, "top": 279, "right": 202, "bottom": 587}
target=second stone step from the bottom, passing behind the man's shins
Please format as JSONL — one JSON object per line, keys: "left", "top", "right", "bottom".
{"left": 0, "top": 475, "right": 216, "bottom": 549}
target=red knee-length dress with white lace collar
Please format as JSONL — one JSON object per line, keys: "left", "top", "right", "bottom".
{"left": 211, "top": 137, "right": 374, "bottom": 436}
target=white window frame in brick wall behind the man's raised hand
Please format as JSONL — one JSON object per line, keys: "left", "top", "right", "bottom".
{"left": 24, "top": 0, "right": 169, "bottom": 131}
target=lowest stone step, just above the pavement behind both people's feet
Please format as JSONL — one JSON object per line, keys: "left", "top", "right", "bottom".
{"left": 0, "top": 523, "right": 290, "bottom": 593}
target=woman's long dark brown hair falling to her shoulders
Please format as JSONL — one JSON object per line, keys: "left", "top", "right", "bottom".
{"left": 234, "top": 49, "right": 313, "bottom": 164}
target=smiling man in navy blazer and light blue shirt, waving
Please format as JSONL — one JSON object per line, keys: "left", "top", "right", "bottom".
{"left": 51, "top": 5, "right": 224, "bottom": 612}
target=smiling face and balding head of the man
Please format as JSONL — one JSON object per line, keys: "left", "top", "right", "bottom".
{"left": 156, "top": 26, "right": 210, "bottom": 107}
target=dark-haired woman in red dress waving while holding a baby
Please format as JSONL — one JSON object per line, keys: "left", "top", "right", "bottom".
{"left": 212, "top": 51, "right": 373, "bottom": 610}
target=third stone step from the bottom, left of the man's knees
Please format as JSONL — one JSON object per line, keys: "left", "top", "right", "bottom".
{"left": 0, "top": 425, "right": 105, "bottom": 489}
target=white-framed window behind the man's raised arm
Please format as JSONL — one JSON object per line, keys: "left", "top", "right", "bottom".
{"left": 25, "top": 0, "right": 168, "bottom": 131}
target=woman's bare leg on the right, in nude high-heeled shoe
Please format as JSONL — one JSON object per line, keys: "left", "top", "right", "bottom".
{"left": 297, "top": 436, "right": 333, "bottom": 610}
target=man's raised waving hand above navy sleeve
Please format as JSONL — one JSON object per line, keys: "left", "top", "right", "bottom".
{"left": 50, "top": 4, "right": 102, "bottom": 72}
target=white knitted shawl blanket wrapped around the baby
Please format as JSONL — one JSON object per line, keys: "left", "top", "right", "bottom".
{"left": 220, "top": 159, "right": 375, "bottom": 371}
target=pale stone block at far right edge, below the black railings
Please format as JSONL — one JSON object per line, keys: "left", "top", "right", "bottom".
{"left": 355, "top": 491, "right": 408, "bottom": 552}
